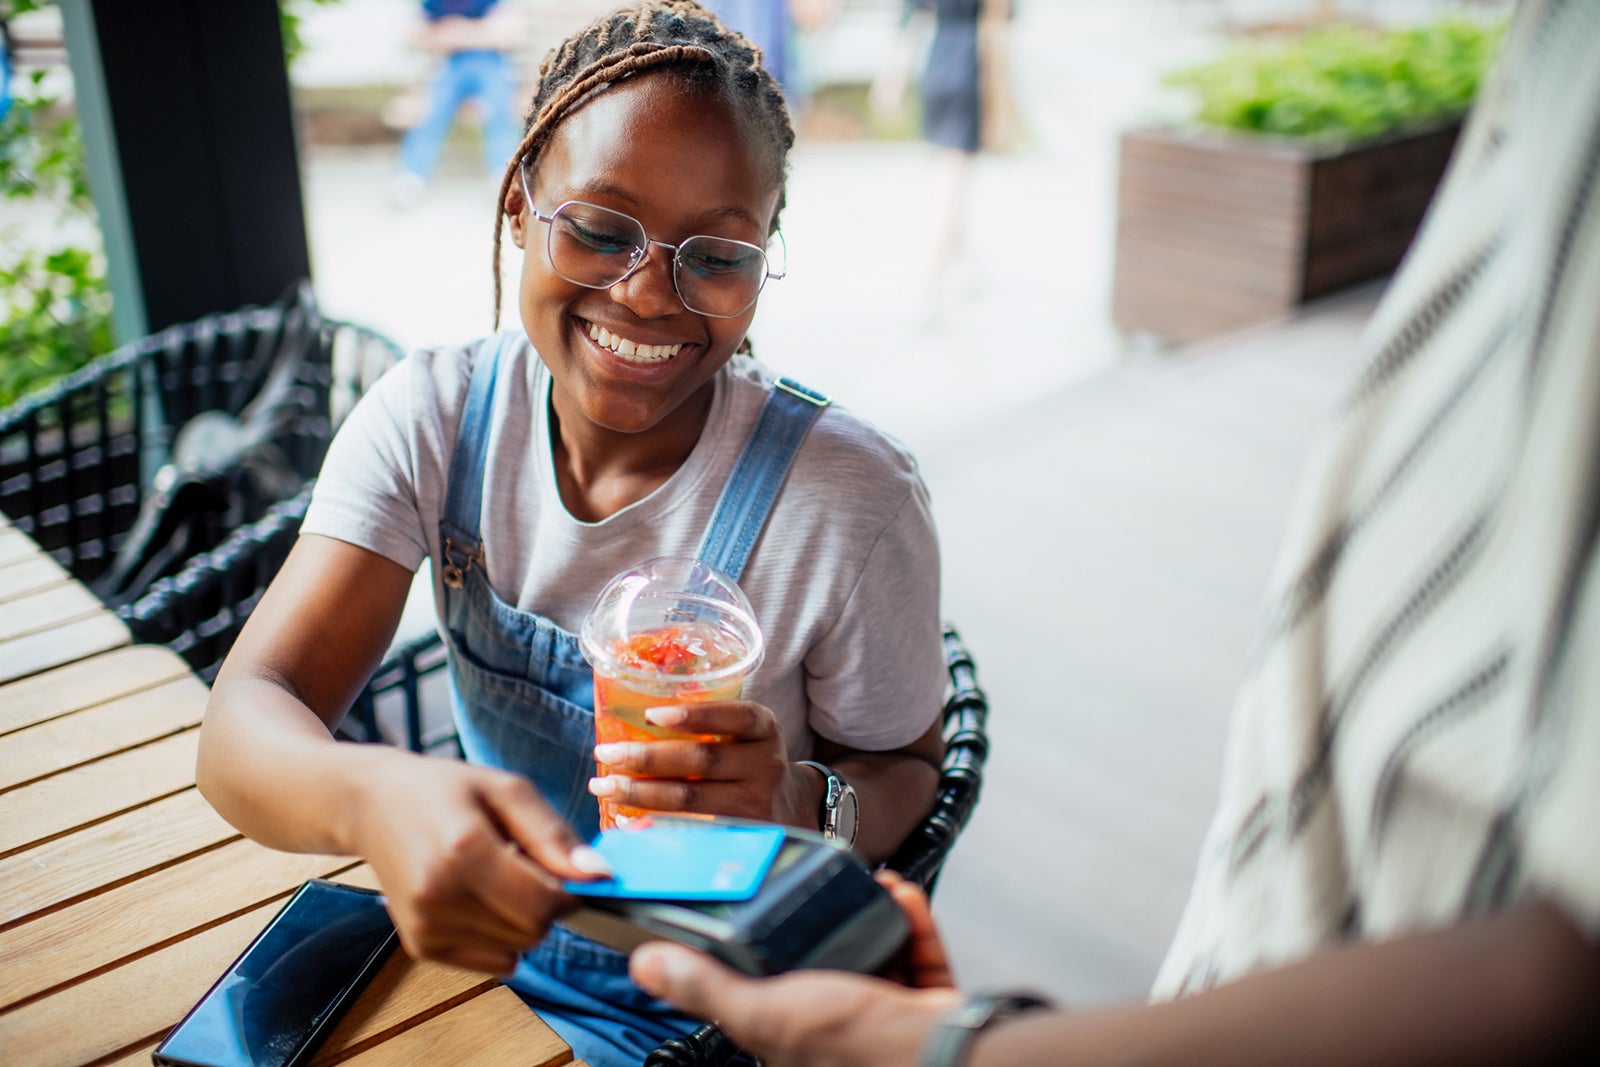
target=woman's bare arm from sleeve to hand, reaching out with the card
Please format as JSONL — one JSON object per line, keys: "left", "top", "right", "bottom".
{"left": 197, "top": 536, "right": 603, "bottom": 974}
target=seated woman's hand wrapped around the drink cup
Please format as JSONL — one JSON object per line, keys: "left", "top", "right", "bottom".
{"left": 589, "top": 701, "right": 822, "bottom": 830}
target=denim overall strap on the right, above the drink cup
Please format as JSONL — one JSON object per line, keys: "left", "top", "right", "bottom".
{"left": 696, "top": 378, "right": 829, "bottom": 581}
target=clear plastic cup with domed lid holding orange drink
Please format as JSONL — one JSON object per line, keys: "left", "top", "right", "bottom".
{"left": 579, "top": 557, "right": 763, "bottom": 829}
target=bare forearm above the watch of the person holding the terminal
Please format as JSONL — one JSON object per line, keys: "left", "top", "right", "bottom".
{"left": 971, "top": 904, "right": 1600, "bottom": 1067}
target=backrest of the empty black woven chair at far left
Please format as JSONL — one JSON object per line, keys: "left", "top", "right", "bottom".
{"left": 0, "top": 283, "right": 398, "bottom": 606}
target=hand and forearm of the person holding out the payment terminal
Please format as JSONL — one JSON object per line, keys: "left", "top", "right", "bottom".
{"left": 632, "top": 902, "right": 1600, "bottom": 1067}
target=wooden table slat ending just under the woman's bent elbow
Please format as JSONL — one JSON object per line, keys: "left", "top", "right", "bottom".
{"left": 0, "top": 789, "right": 238, "bottom": 928}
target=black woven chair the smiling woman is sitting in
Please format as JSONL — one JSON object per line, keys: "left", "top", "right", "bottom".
{"left": 645, "top": 624, "right": 989, "bottom": 1067}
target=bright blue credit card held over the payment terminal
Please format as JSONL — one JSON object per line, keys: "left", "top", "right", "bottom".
{"left": 565, "top": 821, "right": 784, "bottom": 901}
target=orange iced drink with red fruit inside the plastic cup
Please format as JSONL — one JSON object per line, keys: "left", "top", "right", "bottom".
{"left": 595, "top": 624, "right": 746, "bottom": 830}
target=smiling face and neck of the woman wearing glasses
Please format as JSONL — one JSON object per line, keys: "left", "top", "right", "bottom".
{"left": 507, "top": 72, "right": 778, "bottom": 454}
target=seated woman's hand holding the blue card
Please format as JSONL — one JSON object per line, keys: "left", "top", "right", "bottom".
{"left": 350, "top": 750, "right": 606, "bottom": 974}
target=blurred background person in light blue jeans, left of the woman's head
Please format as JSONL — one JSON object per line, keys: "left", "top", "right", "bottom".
{"left": 390, "top": 0, "right": 522, "bottom": 206}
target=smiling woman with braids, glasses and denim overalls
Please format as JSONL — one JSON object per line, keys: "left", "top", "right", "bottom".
{"left": 200, "top": 0, "right": 946, "bottom": 1067}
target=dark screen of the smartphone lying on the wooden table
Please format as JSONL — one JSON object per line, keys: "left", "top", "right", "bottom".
{"left": 155, "top": 880, "right": 397, "bottom": 1067}
